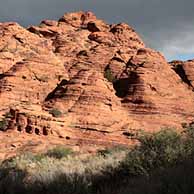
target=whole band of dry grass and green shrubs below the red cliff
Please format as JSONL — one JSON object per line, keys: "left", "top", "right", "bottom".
{"left": 0, "top": 125, "right": 194, "bottom": 194}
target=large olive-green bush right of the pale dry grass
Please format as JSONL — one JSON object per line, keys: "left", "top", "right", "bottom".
{"left": 122, "top": 129, "right": 193, "bottom": 176}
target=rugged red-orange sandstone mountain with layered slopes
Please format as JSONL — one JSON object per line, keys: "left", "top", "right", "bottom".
{"left": 0, "top": 12, "right": 194, "bottom": 158}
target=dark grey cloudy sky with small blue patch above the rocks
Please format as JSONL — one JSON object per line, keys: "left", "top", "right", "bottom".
{"left": 0, "top": 0, "right": 194, "bottom": 60}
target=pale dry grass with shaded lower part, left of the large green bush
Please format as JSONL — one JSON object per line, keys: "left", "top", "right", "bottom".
{"left": 0, "top": 147, "right": 127, "bottom": 194}
